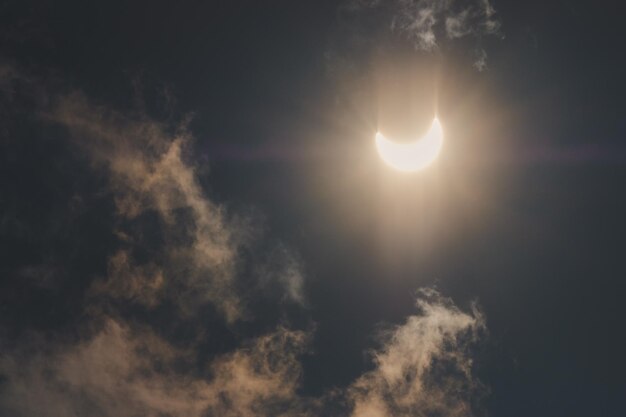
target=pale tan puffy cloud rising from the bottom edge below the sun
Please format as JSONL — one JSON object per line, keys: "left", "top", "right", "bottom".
{"left": 349, "top": 290, "right": 484, "bottom": 417}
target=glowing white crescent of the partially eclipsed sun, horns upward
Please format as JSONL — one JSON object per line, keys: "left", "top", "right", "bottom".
{"left": 376, "top": 117, "right": 443, "bottom": 172}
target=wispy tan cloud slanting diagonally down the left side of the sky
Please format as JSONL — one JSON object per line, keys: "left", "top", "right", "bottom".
{"left": 48, "top": 94, "right": 243, "bottom": 321}
